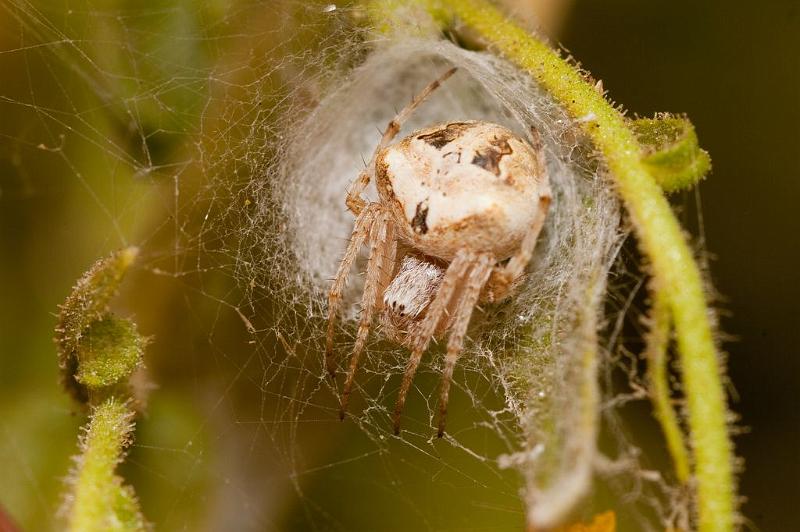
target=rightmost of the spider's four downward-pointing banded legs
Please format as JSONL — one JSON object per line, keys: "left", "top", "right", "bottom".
{"left": 438, "top": 254, "right": 495, "bottom": 438}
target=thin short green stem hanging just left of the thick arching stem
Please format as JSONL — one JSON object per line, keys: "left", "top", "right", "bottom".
{"left": 645, "top": 292, "right": 691, "bottom": 484}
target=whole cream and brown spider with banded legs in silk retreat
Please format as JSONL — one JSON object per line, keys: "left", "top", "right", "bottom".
{"left": 325, "top": 68, "right": 551, "bottom": 437}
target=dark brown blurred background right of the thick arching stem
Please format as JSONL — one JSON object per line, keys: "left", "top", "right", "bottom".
{"left": 561, "top": 0, "right": 800, "bottom": 531}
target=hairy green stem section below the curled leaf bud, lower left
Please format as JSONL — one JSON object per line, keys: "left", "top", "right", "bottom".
{"left": 69, "top": 397, "right": 146, "bottom": 532}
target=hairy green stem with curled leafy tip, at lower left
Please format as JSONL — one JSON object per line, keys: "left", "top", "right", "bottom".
{"left": 55, "top": 248, "right": 149, "bottom": 532}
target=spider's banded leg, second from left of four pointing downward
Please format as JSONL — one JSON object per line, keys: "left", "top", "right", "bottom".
{"left": 339, "top": 212, "right": 397, "bottom": 420}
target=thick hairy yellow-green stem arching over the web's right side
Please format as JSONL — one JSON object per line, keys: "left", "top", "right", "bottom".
{"left": 366, "top": 0, "right": 736, "bottom": 532}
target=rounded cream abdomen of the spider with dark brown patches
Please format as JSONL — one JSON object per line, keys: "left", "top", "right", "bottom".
{"left": 376, "top": 121, "right": 550, "bottom": 260}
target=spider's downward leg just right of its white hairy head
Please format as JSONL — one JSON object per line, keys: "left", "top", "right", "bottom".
{"left": 394, "top": 251, "right": 475, "bottom": 435}
